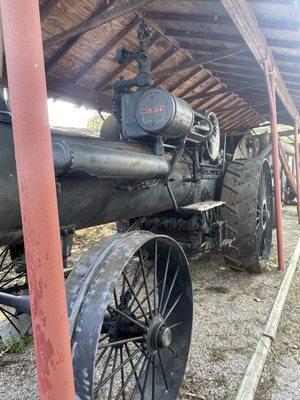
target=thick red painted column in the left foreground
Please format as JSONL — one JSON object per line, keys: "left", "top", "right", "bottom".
{"left": 0, "top": 0, "right": 75, "bottom": 400}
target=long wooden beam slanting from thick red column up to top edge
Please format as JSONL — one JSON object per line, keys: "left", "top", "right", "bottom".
{"left": 44, "top": 0, "right": 154, "bottom": 48}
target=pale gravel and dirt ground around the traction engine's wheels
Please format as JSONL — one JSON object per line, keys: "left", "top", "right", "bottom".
{"left": 0, "top": 207, "right": 300, "bottom": 400}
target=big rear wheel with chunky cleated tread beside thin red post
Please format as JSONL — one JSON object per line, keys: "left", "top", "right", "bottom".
{"left": 222, "top": 158, "right": 273, "bottom": 272}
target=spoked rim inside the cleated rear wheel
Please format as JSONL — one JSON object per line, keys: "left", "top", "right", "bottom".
{"left": 256, "top": 162, "right": 273, "bottom": 260}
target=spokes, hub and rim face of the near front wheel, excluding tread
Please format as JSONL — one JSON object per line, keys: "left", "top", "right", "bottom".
{"left": 68, "top": 231, "right": 192, "bottom": 400}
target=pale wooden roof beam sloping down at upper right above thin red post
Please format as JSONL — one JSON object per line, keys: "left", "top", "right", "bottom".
{"left": 221, "top": 0, "right": 299, "bottom": 119}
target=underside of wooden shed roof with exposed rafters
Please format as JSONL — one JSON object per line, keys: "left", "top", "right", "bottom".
{"left": 26, "top": 0, "right": 300, "bottom": 134}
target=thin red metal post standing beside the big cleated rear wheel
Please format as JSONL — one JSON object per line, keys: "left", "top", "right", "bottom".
{"left": 263, "top": 60, "right": 285, "bottom": 271}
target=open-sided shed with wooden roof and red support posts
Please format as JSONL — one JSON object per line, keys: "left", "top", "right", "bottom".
{"left": 0, "top": 0, "right": 300, "bottom": 399}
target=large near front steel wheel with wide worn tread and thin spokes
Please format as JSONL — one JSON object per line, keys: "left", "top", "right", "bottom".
{"left": 67, "top": 231, "right": 192, "bottom": 400}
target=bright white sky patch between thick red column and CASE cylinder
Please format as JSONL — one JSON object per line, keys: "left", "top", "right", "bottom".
{"left": 48, "top": 99, "right": 97, "bottom": 128}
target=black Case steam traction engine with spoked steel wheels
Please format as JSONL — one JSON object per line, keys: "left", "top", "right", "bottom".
{"left": 0, "top": 23, "right": 272, "bottom": 400}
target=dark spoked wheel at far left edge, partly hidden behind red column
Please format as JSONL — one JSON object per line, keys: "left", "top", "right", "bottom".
{"left": 0, "top": 247, "right": 28, "bottom": 333}
